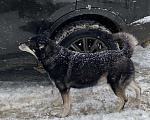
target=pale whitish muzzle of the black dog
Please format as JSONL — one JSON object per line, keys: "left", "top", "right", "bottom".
{"left": 19, "top": 43, "right": 38, "bottom": 59}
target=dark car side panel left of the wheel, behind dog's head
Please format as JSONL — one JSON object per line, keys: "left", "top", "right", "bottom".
{"left": 0, "top": 0, "right": 76, "bottom": 71}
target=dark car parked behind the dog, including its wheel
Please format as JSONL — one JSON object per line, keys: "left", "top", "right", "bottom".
{"left": 0, "top": 0, "right": 150, "bottom": 71}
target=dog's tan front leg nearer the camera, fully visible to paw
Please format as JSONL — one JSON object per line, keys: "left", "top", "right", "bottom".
{"left": 57, "top": 89, "right": 70, "bottom": 118}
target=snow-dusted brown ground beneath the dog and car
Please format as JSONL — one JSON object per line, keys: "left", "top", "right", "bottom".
{"left": 0, "top": 46, "right": 150, "bottom": 120}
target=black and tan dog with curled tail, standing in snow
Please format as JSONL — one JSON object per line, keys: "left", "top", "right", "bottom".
{"left": 19, "top": 32, "right": 141, "bottom": 118}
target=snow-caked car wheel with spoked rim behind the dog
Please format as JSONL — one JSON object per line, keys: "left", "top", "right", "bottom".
{"left": 55, "top": 20, "right": 117, "bottom": 53}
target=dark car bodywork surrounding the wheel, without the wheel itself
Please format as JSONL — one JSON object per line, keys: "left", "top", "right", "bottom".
{"left": 0, "top": 0, "right": 150, "bottom": 70}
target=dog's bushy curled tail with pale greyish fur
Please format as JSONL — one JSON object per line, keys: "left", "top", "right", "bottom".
{"left": 113, "top": 32, "right": 138, "bottom": 58}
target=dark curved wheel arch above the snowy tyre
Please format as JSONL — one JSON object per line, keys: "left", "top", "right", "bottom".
{"left": 41, "top": 8, "right": 126, "bottom": 39}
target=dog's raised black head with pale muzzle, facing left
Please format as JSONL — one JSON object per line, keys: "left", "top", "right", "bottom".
{"left": 19, "top": 36, "right": 49, "bottom": 58}
